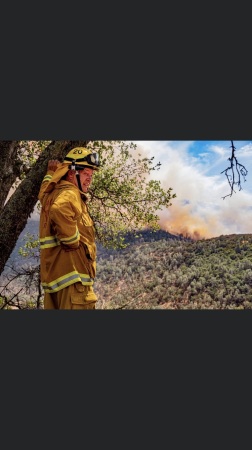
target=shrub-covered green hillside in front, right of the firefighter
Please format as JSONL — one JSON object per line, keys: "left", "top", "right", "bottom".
{"left": 95, "top": 234, "right": 252, "bottom": 309}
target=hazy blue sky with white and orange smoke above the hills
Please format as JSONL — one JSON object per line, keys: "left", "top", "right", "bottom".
{"left": 134, "top": 141, "right": 252, "bottom": 238}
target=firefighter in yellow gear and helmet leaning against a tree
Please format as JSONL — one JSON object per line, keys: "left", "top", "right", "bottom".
{"left": 38, "top": 147, "right": 99, "bottom": 310}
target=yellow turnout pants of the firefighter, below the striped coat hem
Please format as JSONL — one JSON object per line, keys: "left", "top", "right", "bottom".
{"left": 44, "top": 282, "right": 97, "bottom": 310}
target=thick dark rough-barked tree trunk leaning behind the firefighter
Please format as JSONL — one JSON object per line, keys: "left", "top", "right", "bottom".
{"left": 0, "top": 141, "right": 89, "bottom": 275}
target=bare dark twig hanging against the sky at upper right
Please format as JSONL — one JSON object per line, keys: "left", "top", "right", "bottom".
{"left": 221, "top": 141, "right": 248, "bottom": 199}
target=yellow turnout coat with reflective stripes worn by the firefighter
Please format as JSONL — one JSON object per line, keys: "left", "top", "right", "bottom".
{"left": 38, "top": 171, "right": 96, "bottom": 293}
